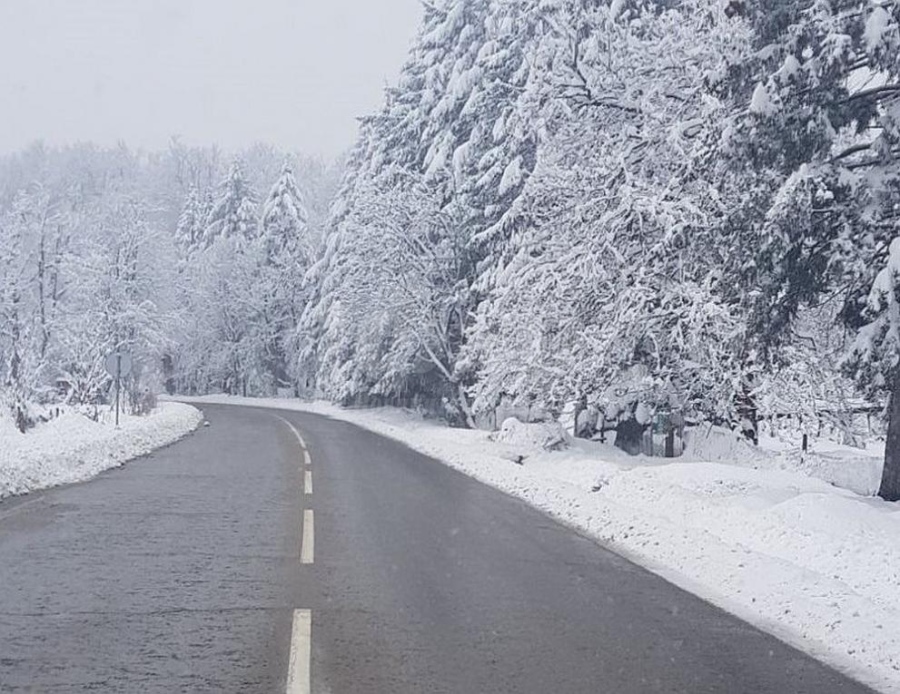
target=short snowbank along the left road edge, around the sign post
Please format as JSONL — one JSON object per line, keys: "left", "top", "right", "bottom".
{"left": 0, "top": 402, "right": 203, "bottom": 499}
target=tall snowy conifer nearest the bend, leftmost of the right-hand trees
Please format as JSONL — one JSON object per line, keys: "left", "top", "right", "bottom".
{"left": 310, "top": 0, "right": 500, "bottom": 421}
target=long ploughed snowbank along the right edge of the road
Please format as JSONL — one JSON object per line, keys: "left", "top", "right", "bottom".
{"left": 184, "top": 396, "right": 900, "bottom": 693}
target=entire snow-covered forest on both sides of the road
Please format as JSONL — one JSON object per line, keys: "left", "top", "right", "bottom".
{"left": 0, "top": 0, "right": 900, "bottom": 500}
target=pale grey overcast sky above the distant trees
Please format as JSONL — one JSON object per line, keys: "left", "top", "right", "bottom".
{"left": 0, "top": 0, "right": 421, "bottom": 156}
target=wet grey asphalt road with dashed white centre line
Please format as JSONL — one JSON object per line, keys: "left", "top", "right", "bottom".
{"left": 0, "top": 406, "right": 870, "bottom": 694}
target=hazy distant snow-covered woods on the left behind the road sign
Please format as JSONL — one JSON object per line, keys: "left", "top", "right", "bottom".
{"left": 0, "top": 140, "right": 339, "bottom": 431}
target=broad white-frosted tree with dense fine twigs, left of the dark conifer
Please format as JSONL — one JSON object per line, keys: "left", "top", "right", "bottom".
{"left": 471, "top": 1, "right": 746, "bottom": 440}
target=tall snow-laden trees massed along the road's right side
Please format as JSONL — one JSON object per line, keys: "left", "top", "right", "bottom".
{"left": 304, "top": 0, "right": 900, "bottom": 498}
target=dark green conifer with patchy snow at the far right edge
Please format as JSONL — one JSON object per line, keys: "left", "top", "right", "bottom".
{"left": 724, "top": 0, "right": 900, "bottom": 496}
